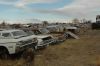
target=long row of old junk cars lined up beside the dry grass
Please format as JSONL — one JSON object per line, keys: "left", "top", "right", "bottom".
{"left": 0, "top": 24, "right": 79, "bottom": 59}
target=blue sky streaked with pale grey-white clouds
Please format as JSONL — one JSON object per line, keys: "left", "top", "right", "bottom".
{"left": 0, "top": 0, "right": 100, "bottom": 23}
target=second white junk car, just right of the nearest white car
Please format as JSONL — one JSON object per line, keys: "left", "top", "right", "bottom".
{"left": 23, "top": 29, "right": 55, "bottom": 49}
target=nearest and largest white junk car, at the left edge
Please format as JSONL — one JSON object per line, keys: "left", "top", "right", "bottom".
{"left": 0, "top": 30, "right": 36, "bottom": 56}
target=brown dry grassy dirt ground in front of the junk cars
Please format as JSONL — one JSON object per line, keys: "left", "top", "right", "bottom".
{"left": 0, "top": 30, "right": 100, "bottom": 66}
